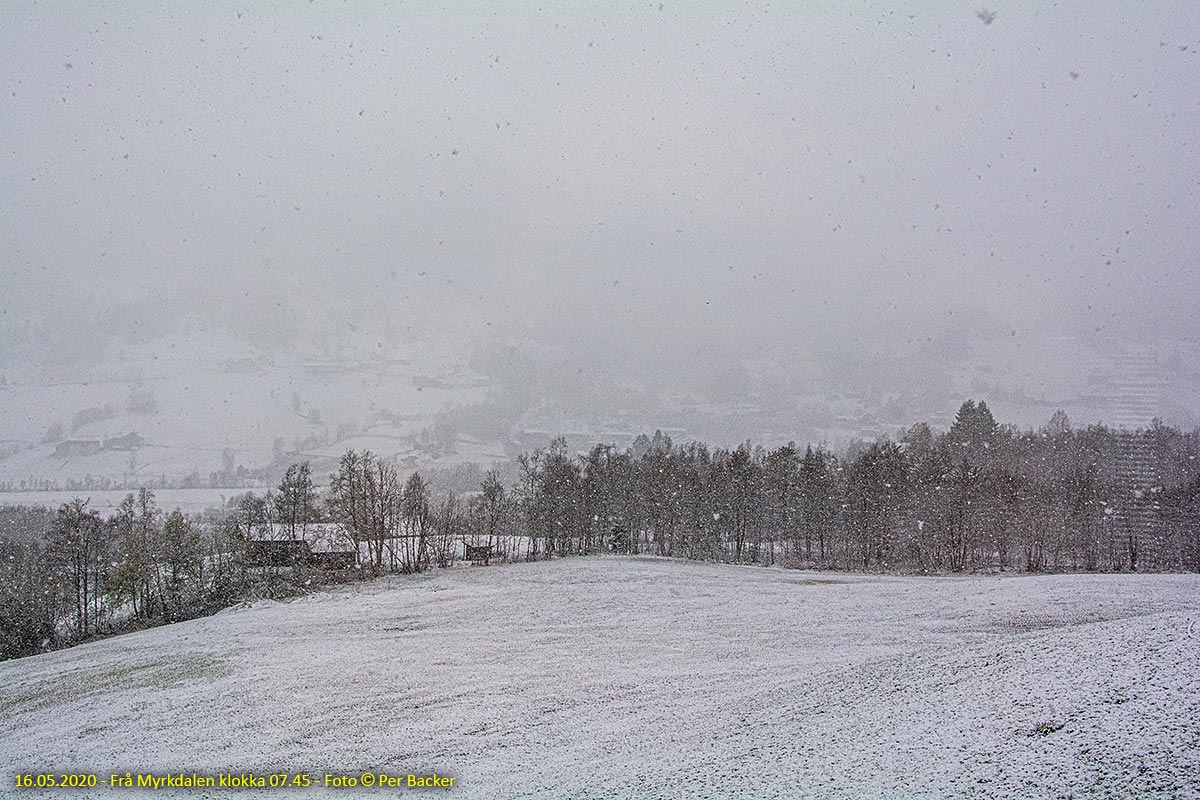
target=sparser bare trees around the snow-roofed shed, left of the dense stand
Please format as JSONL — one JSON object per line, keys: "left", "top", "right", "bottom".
{"left": 0, "top": 460, "right": 482, "bottom": 658}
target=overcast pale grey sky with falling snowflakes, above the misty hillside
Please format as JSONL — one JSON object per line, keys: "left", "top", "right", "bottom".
{"left": 0, "top": 0, "right": 1200, "bottom": 388}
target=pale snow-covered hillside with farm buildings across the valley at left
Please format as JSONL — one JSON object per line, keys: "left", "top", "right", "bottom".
{"left": 0, "top": 330, "right": 508, "bottom": 494}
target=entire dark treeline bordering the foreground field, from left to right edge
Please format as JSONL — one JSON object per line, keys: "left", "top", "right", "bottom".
{"left": 0, "top": 402, "right": 1200, "bottom": 658}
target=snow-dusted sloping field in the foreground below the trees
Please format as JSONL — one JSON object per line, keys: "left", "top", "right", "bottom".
{"left": 0, "top": 558, "right": 1200, "bottom": 799}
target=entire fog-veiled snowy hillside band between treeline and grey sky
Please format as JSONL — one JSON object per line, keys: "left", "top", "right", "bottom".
{"left": 0, "top": 330, "right": 1200, "bottom": 509}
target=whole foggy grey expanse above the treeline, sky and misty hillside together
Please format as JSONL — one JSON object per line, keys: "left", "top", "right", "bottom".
{"left": 0, "top": 1, "right": 1200, "bottom": 499}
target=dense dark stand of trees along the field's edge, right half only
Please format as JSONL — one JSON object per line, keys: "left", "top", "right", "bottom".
{"left": 504, "top": 402, "right": 1200, "bottom": 572}
